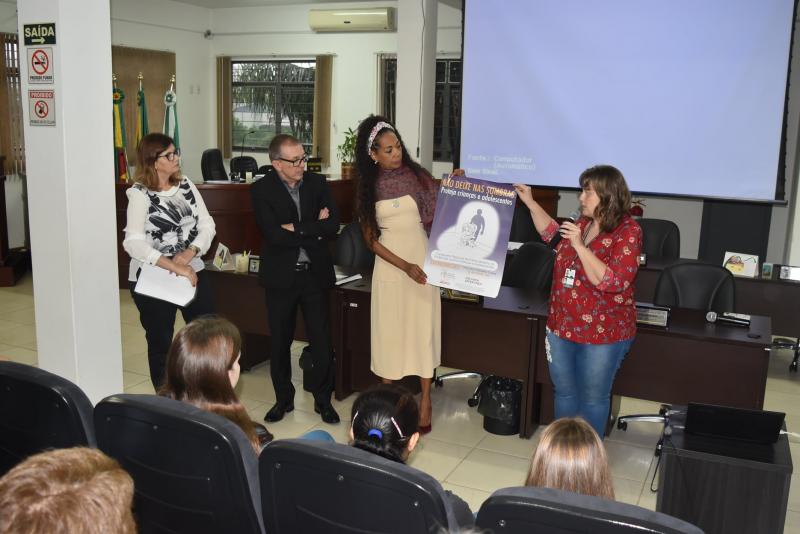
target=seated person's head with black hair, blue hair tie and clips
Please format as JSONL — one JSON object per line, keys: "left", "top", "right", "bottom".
{"left": 350, "top": 384, "right": 419, "bottom": 462}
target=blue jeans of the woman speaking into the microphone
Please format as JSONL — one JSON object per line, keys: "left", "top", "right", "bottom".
{"left": 545, "top": 330, "right": 633, "bottom": 438}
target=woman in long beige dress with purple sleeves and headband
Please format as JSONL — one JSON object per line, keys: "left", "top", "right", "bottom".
{"left": 356, "top": 115, "right": 441, "bottom": 434}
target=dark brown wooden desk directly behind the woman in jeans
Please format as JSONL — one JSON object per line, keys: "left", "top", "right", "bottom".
{"left": 535, "top": 308, "right": 772, "bottom": 423}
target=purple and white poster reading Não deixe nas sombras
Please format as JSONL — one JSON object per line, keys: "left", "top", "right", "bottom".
{"left": 423, "top": 176, "right": 517, "bottom": 298}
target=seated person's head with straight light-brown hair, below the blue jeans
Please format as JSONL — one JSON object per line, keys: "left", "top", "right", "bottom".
{"left": 525, "top": 417, "right": 614, "bottom": 499}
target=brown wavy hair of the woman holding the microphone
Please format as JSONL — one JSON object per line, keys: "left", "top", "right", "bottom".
{"left": 578, "top": 165, "right": 631, "bottom": 232}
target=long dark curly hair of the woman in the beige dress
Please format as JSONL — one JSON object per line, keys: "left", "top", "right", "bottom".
{"left": 356, "top": 115, "right": 426, "bottom": 245}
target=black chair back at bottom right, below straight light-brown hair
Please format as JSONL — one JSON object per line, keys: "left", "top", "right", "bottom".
{"left": 476, "top": 487, "right": 703, "bottom": 534}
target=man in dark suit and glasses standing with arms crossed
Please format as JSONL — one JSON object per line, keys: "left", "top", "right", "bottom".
{"left": 251, "top": 134, "right": 339, "bottom": 423}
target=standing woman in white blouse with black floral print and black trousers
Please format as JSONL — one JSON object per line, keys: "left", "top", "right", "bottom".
{"left": 122, "top": 133, "right": 216, "bottom": 390}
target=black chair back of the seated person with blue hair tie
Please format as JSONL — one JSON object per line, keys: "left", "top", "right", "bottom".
{"left": 259, "top": 439, "right": 457, "bottom": 534}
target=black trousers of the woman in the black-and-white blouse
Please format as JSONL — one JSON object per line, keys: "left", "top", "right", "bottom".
{"left": 130, "top": 271, "right": 215, "bottom": 391}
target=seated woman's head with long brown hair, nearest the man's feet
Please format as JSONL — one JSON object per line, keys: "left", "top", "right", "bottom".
{"left": 158, "top": 316, "right": 272, "bottom": 451}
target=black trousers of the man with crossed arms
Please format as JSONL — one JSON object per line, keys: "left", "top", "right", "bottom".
{"left": 265, "top": 271, "right": 334, "bottom": 403}
